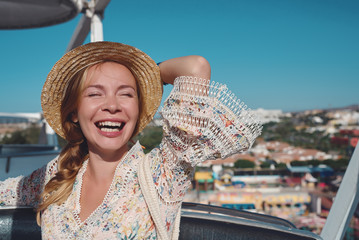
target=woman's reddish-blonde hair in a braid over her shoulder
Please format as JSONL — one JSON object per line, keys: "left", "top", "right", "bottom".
{"left": 36, "top": 66, "right": 90, "bottom": 225}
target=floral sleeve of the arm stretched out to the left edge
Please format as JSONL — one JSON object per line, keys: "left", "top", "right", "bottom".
{"left": 0, "top": 158, "right": 57, "bottom": 207}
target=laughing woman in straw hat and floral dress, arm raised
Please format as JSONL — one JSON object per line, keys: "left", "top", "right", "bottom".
{"left": 0, "top": 42, "right": 261, "bottom": 239}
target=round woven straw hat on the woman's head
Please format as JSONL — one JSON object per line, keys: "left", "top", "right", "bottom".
{"left": 41, "top": 42, "right": 163, "bottom": 138}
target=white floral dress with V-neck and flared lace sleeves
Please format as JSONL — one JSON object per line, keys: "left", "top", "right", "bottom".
{"left": 0, "top": 77, "right": 261, "bottom": 239}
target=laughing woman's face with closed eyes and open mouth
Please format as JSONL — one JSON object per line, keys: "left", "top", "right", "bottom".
{"left": 73, "top": 62, "right": 139, "bottom": 156}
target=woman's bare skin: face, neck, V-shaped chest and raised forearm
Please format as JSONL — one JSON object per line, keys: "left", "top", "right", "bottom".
{"left": 73, "top": 56, "right": 211, "bottom": 222}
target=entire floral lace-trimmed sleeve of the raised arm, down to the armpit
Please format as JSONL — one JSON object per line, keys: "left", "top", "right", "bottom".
{"left": 150, "top": 77, "right": 262, "bottom": 234}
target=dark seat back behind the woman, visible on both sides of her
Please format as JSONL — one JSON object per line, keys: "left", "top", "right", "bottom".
{"left": 0, "top": 204, "right": 321, "bottom": 240}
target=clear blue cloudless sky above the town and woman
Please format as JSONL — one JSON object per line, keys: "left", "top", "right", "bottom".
{"left": 0, "top": 0, "right": 359, "bottom": 112}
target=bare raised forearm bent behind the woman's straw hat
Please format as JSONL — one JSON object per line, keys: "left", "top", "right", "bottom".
{"left": 159, "top": 55, "right": 211, "bottom": 84}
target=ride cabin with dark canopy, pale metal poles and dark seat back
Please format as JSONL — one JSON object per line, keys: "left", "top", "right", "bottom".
{"left": 0, "top": 0, "right": 359, "bottom": 240}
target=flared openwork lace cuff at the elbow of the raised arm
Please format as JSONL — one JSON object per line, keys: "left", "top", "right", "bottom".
{"left": 161, "top": 77, "right": 262, "bottom": 167}
